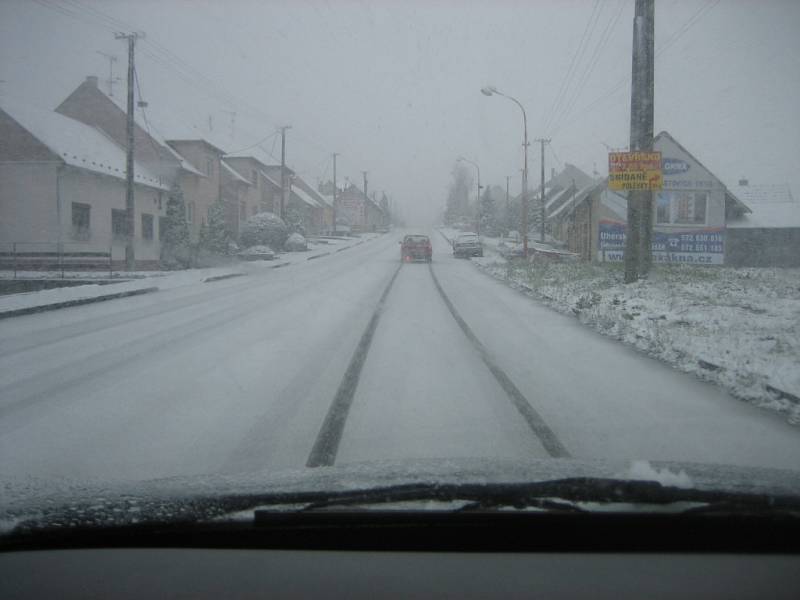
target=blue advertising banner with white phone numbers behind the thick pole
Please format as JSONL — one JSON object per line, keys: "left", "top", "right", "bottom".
{"left": 598, "top": 219, "right": 725, "bottom": 265}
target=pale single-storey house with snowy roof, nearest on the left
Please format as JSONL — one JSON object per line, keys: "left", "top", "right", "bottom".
{"left": 0, "top": 102, "right": 169, "bottom": 268}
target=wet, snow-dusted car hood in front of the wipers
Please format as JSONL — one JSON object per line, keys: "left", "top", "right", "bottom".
{"left": 0, "top": 458, "right": 800, "bottom": 534}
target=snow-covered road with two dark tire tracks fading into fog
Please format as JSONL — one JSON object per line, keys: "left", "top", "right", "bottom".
{"left": 0, "top": 232, "right": 800, "bottom": 480}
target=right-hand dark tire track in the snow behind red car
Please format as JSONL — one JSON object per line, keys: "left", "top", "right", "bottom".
{"left": 428, "top": 265, "right": 570, "bottom": 458}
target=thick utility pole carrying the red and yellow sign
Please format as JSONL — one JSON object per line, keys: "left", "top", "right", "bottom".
{"left": 625, "top": 0, "right": 655, "bottom": 283}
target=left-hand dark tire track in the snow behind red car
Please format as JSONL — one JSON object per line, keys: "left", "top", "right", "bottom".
{"left": 306, "top": 263, "right": 403, "bottom": 467}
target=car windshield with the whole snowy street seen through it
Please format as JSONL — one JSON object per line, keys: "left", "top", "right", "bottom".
{"left": 0, "top": 0, "right": 800, "bottom": 537}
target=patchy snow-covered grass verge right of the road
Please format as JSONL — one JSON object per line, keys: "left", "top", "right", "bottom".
{"left": 438, "top": 227, "right": 800, "bottom": 425}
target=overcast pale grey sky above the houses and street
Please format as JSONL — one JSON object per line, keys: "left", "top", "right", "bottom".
{"left": 0, "top": 0, "right": 800, "bottom": 221}
